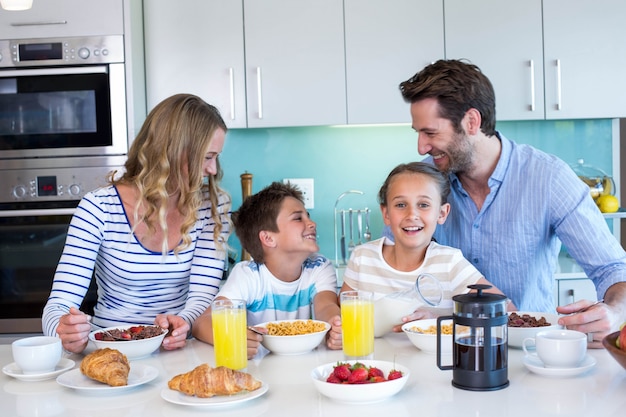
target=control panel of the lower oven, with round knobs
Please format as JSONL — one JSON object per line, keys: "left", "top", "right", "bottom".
{"left": 0, "top": 166, "right": 124, "bottom": 203}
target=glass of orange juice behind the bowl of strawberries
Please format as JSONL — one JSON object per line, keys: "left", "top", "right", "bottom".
{"left": 340, "top": 291, "right": 374, "bottom": 359}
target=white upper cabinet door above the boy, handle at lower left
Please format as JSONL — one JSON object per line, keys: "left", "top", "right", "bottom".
{"left": 244, "top": 0, "right": 346, "bottom": 127}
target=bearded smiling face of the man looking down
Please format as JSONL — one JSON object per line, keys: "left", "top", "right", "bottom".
{"left": 411, "top": 98, "right": 476, "bottom": 173}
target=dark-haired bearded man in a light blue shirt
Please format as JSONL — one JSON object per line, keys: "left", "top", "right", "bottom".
{"left": 400, "top": 60, "right": 626, "bottom": 347}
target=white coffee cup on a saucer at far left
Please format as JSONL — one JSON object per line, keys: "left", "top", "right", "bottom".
{"left": 11, "top": 336, "right": 63, "bottom": 374}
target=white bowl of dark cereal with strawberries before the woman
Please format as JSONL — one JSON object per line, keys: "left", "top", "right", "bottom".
{"left": 89, "top": 324, "right": 167, "bottom": 360}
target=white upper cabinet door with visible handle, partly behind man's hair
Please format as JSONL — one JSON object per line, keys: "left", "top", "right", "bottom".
{"left": 444, "top": 0, "right": 545, "bottom": 120}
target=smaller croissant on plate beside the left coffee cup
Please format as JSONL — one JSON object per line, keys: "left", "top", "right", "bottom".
{"left": 80, "top": 348, "right": 130, "bottom": 387}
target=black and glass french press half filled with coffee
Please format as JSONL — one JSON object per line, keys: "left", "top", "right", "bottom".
{"left": 437, "top": 284, "right": 509, "bottom": 391}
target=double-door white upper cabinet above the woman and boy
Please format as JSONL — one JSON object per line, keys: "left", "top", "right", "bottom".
{"left": 144, "top": 0, "right": 346, "bottom": 127}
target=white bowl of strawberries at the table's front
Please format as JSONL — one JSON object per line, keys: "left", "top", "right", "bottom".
{"left": 311, "top": 360, "right": 410, "bottom": 404}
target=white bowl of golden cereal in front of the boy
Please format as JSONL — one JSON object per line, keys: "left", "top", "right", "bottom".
{"left": 254, "top": 320, "right": 330, "bottom": 355}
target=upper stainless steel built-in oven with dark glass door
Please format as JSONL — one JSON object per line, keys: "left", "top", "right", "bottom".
{"left": 0, "top": 35, "right": 128, "bottom": 160}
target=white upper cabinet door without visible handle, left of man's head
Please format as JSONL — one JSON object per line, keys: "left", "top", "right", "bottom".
{"left": 344, "top": 0, "right": 444, "bottom": 124}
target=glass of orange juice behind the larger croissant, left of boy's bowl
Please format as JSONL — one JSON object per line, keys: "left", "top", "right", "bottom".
{"left": 211, "top": 299, "right": 248, "bottom": 370}
